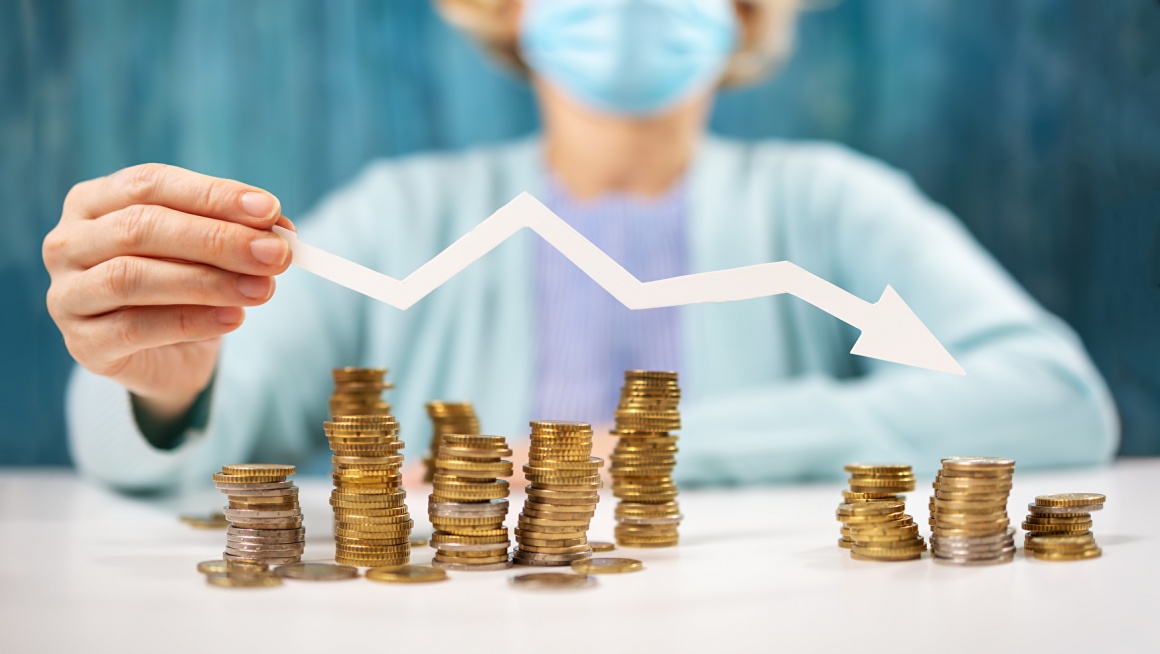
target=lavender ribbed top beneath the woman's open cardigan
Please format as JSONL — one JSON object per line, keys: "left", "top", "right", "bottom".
{"left": 532, "top": 175, "right": 688, "bottom": 427}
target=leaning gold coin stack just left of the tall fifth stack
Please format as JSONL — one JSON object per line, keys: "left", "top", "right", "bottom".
{"left": 514, "top": 421, "right": 604, "bottom": 566}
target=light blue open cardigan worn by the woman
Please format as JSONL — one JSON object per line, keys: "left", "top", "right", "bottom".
{"left": 70, "top": 138, "right": 1118, "bottom": 488}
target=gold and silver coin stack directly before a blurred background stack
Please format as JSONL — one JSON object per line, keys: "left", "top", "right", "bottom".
{"left": 427, "top": 434, "right": 512, "bottom": 571}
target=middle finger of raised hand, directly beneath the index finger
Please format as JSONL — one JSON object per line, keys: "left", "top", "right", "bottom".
{"left": 61, "top": 204, "right": 290, "bottom": 276}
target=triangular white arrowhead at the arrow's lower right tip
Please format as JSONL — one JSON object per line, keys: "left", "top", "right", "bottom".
{"left": 850, "top": 285, "right": 966, "bottom": 376}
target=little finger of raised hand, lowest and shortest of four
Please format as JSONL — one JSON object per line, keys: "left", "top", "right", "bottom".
{"left": 73, "top": 305, "right": 246, "bottom": 364}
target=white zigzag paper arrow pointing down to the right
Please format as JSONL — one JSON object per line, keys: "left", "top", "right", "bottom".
{"left": 274, "top": 192, "right": 966, "bottom": 375}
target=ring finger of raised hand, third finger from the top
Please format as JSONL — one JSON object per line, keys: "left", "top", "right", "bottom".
{"left": 51, "top": 256, "right": 274, "bottom": 318}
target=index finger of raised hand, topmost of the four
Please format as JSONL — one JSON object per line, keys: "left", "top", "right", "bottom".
{"left": 65, "top": 164, "right": 281, "bottom": 230}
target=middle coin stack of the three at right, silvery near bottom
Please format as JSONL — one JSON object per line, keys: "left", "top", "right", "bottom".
{"left": 930, "top": 457, "right": 1015, "bottom": 566}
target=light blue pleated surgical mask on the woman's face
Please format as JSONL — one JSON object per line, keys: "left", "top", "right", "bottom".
{"left": 520, "top": 0, "right": 738, "bottom": 116}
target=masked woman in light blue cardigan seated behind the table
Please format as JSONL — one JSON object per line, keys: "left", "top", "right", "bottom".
{"left": 44, "top": 0, "right": 1116, "bottom": 488}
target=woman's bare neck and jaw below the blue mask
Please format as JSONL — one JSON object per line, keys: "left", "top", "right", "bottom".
{"left": 535, "top": 81, "right": 712, "bottom": 198}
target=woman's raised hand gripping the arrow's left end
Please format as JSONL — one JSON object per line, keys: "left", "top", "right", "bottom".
{"left": 43, "top": 164, "right": 292, "bottom": 420}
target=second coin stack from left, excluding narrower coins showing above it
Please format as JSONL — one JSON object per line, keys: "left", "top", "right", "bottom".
{"left": 324, "top": 415, "right": 414, "bottom": 567}
